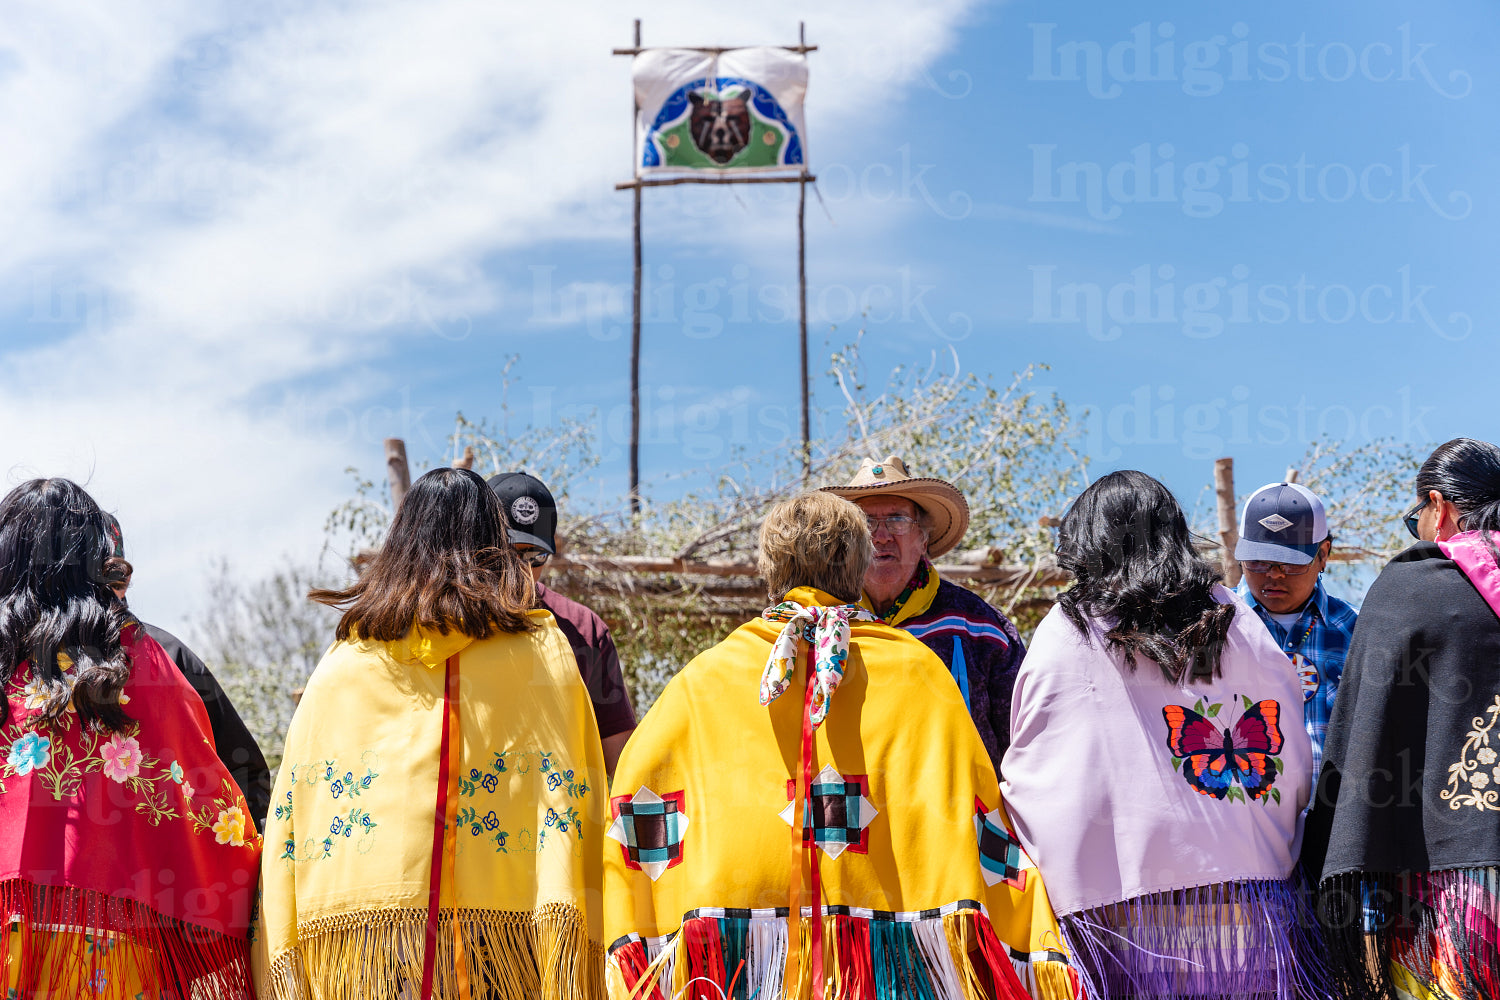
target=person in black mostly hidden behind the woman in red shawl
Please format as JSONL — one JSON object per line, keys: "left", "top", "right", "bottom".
{"left": 104, "top": 513, "right": 272, "bottom": 831}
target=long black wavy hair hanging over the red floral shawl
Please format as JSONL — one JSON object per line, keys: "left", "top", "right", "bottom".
{"left": 0, "top": 478, "right": 132, "bottom": 732}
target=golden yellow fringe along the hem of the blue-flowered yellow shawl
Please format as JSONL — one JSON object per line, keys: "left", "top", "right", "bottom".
{"left": 258, "top": 903, "right": 605, "bottom": 1000}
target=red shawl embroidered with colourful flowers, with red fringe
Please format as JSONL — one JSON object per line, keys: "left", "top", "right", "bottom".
{"left": 0, "top": 625, "right": 261, "bottom": 997}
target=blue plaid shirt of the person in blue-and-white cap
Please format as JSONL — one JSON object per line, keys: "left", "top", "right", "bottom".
{"left": 1236, "top": 579, "right": 1359, "bottom": 781}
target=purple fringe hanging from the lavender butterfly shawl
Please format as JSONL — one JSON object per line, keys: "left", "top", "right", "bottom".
{"left": 1059, "top": 879, "right": 1329, "bottom": 1000}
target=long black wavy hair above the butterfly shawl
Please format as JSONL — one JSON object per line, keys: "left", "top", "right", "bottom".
{"left": 1058, "top": 471, "right": 1235, "bottom": 684}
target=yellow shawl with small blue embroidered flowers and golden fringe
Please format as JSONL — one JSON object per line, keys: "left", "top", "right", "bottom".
{"left": 254, "top": 610, "right": 606, "bottom": 1000}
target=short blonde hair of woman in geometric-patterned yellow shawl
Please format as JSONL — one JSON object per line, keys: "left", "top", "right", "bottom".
{"left": 756, "top": 492, "right": 875, "bottom": 604}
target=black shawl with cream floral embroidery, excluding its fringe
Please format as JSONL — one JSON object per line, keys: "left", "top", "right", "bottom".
{"left": 1304, "top": 541, "right": 1500, "bottom": 879}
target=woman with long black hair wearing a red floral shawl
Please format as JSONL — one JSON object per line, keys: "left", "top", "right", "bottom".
{"left": 0, "top": 478, "right": 261, "bottom": 999}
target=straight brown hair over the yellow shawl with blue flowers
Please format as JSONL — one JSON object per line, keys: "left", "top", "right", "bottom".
{"left": 308, "top": 469, "right": 536, "bottom": 642}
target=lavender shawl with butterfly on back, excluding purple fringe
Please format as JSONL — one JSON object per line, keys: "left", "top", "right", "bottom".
{"left": 1001, "top": 586, "right": 1313, "bottom": 916}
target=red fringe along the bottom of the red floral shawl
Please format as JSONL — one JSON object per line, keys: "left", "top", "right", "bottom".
{"left": 0, "top": 879, "right": 252, "bottom": 1000}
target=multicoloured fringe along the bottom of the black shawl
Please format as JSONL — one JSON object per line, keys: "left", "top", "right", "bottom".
{"left": 1317, "top": 867, "right": 1500, "bottom": 1000}
